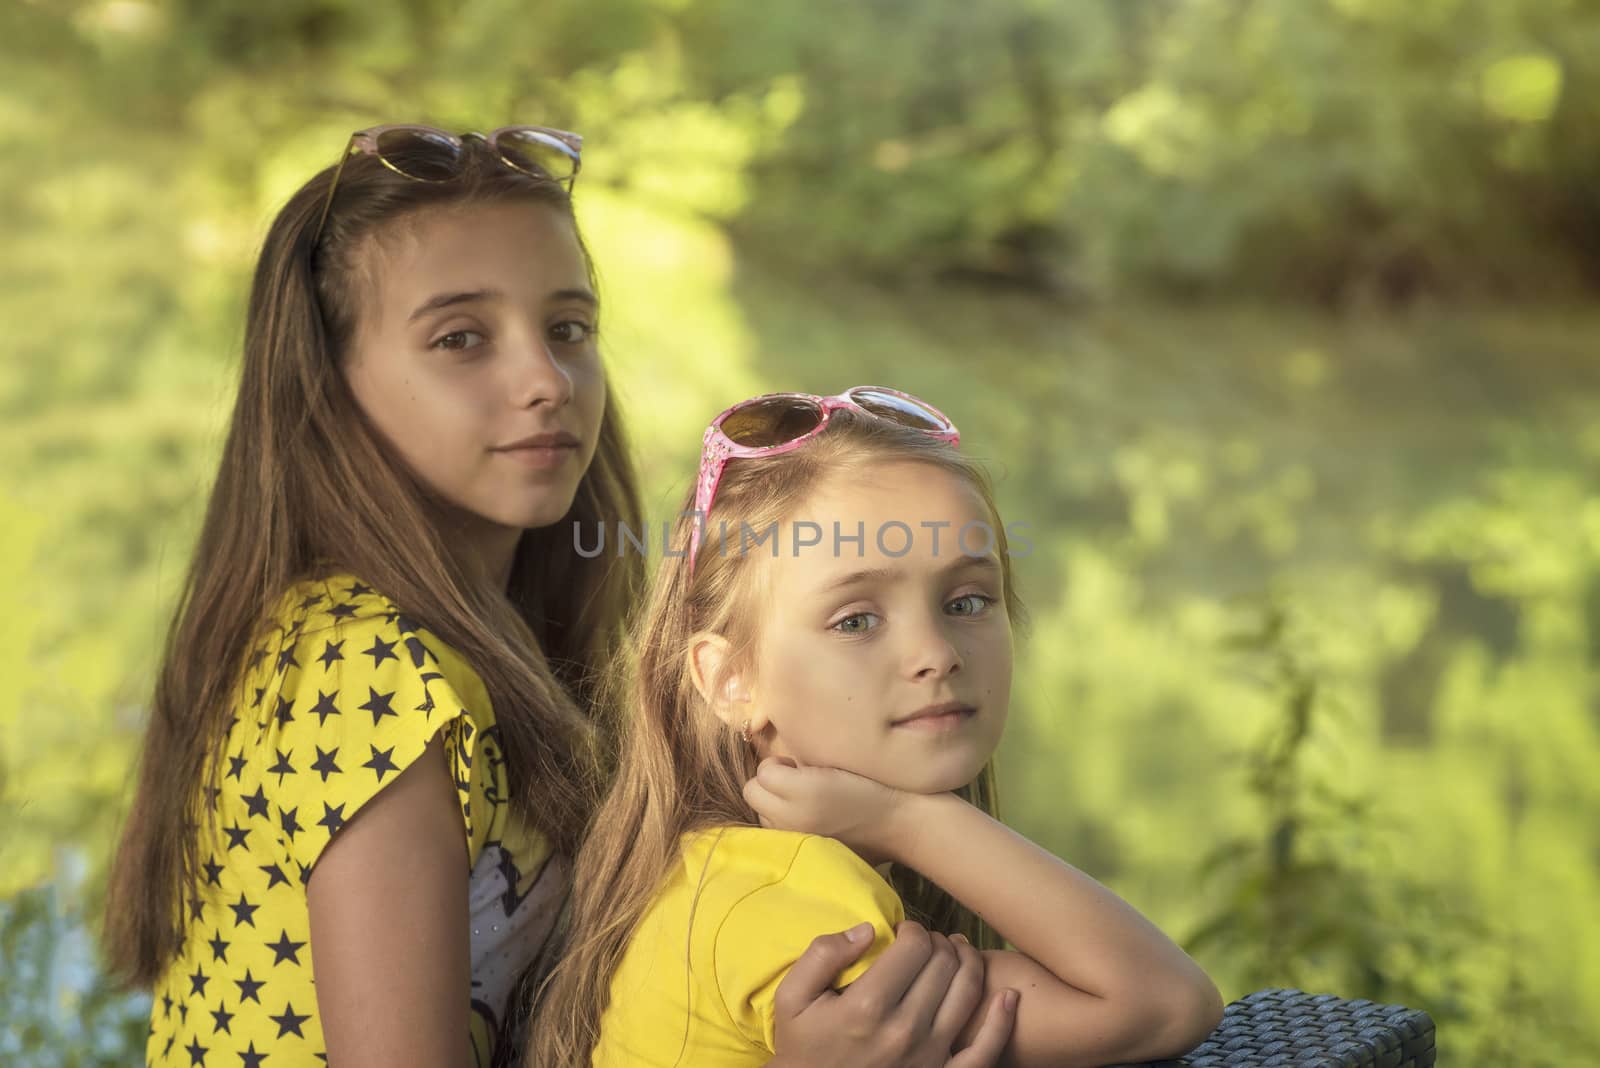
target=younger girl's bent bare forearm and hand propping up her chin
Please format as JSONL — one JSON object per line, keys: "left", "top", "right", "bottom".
{"left": 746, "top": 761, "right": 1222, "bottom": 1068}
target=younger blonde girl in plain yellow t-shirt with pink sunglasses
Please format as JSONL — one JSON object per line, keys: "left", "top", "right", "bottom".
{"left": 528, "top": 387, "right": 1222, "bottom": 1068}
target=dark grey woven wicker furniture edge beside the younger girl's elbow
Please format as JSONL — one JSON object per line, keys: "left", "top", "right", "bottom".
{"left": 1114, "top": 990, "right": 1434, "bottom": 1068}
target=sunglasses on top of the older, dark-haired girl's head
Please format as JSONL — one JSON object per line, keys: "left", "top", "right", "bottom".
{"left": 312, "top": 125, "right": 584, "bottom": 248}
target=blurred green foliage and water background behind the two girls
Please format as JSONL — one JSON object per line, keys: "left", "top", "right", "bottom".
{"left": 0, "top": 0, "right": 1600, "bottom": 1065}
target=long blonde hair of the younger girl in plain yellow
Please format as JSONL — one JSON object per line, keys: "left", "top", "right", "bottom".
{"left": 525, "top": 412, "right": 1019, "bottom": 1068}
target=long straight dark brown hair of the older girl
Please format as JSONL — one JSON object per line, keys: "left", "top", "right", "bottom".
{"left": 106, "top": 139, "right": 643, "bottom": 985}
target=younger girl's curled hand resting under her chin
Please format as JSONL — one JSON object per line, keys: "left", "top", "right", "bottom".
{"left": 744, "top": 756, "right": 914, "bottom": 860}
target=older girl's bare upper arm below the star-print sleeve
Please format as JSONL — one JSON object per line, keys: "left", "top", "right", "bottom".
{"left": 306, "top": 737, "right": 470, "bottom": 1068}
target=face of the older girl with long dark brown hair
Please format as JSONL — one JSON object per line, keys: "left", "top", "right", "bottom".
{"left": 346, "top": 195, "right": 606, "bottom": 545}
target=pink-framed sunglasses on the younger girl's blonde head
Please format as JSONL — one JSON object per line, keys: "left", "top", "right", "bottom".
{"left": 690, "top": 385, "right": 962, "bottom": 576}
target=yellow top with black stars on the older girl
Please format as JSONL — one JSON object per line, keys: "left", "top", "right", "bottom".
{"left": 146, "top": 576, "right": 570, "bottom": 1068}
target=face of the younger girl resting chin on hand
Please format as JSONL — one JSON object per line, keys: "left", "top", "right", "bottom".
{"left": 749, "top": 462, "right": 1011, "bottom": 793}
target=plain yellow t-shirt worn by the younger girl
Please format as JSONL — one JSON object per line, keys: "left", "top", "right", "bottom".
{"left": 592, "top": 827, "right": 906, "bottom": 1068}
